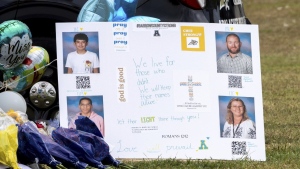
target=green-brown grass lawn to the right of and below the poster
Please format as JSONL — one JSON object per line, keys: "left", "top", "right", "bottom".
{"left": 112, "top": 0, "right": 300, "bottom": 169}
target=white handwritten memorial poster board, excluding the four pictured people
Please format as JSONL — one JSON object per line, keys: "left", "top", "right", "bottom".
{"left": 56, "top": 22, "right": 266, "bottom": 161}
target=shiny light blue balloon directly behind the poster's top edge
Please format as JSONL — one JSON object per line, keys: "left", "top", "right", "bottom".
{"left": 77, "top": 0, "right": 160, "bottom": 22}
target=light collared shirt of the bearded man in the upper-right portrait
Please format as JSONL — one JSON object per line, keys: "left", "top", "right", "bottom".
{"left": 217, "top": 52, "right": 253, "bottom": 74}
